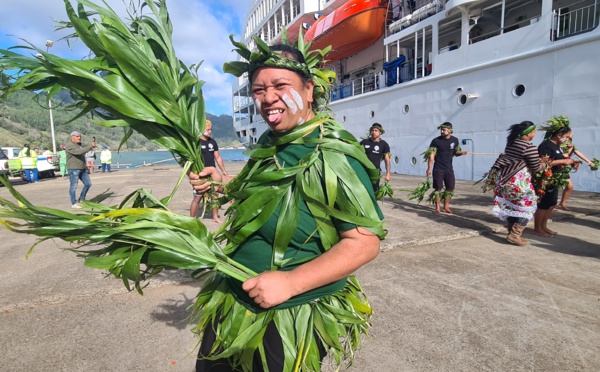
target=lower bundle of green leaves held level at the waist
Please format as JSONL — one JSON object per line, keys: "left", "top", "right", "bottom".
{"left": 0, "top": 178, "right": 256, "bottom": 293}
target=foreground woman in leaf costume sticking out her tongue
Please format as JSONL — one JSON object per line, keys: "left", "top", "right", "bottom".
{"left": 191, "top": 35, "right": 386, "bottom": 371}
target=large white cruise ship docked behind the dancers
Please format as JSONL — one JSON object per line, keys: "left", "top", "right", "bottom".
{"left": 233, "top": 0, "right": 600, "bottom": 192}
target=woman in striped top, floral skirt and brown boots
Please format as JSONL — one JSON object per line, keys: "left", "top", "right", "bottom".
{"left": 492, "top": 121, "right": 544, "bottom": 246}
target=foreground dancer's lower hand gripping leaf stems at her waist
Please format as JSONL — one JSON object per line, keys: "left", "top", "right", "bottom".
{"left": 242, "top": 271, "right": 293, "bottom": 309}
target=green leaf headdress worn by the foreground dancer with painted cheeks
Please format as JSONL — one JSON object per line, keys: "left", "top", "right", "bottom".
{"left": 223, "top": 29, "right": 335, "bottom": 113}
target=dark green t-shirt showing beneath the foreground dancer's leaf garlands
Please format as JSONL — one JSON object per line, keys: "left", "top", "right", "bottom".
{"left": 229, "top": 130, "right": 383, "bottom": 312}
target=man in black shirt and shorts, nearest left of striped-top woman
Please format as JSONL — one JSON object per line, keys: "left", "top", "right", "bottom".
{"left": 427, "top": 121, "right": 467, "bottom": 214}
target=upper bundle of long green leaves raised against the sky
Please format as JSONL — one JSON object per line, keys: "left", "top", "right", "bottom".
{"left": 0, "top": 0, "right": 206, "bottom": 176}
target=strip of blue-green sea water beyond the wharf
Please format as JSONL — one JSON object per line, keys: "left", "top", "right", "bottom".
{"left": 103, "top": 149, "right": 248, "bottom": 168}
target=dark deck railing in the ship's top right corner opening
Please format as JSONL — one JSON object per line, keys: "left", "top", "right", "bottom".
{"left": 552, "top": 1, "right": 599, "bottom": 40}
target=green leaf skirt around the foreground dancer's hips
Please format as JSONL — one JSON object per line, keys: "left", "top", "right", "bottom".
{"left": 191, "top": 271, "right": 373, "bottom": 371}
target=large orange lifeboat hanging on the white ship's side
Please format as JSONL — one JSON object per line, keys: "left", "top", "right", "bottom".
{"left": 304, "top": 0, "right": 388, "bottom": 62}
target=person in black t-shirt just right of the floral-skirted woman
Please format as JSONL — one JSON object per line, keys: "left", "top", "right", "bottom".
{"left": 533, "top": 126, "right": 575, "bottom": 237}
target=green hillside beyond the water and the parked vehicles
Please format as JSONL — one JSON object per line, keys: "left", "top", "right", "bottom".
{"left": 0, "top": 92, "right": 239, "bottom": 151}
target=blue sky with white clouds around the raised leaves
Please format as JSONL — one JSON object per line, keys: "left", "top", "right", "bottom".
{"left": 0, "top": 0, "right": 250, "bottom": 115}
